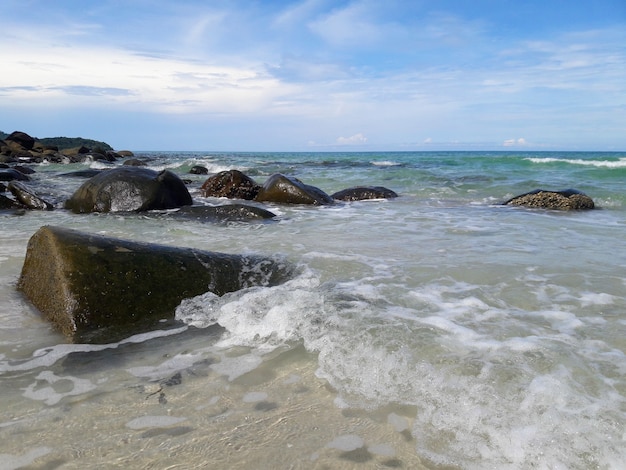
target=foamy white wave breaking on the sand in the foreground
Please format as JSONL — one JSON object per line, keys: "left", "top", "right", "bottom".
{"left": 177, "top": 271, "right": 626, "bottom": 469}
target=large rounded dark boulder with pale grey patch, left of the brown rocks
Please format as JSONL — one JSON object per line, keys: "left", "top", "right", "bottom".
{"left": 65, "top": 166, "right": 193, "bottom": 213}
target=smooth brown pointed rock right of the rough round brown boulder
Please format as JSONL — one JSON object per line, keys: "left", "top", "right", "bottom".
{"left": 255, "top": 173, "right": 334, "bottom": 205}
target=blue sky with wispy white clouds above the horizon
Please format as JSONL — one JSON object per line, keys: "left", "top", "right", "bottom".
{"left": 0, "top": 0, "right": 626, "bottom": 151}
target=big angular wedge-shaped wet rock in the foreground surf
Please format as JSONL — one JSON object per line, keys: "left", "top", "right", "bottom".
{"left": 17, "top": 226, "right": 292, "bottom": 343}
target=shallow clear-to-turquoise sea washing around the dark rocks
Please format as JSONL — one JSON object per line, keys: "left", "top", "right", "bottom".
{"left": 0, "top": 151, "right": 626, "bottom": 470}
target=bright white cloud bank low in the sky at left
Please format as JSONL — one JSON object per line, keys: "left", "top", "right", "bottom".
{"left": 0, "top": 39, "right": 294, "bottom": 113}
